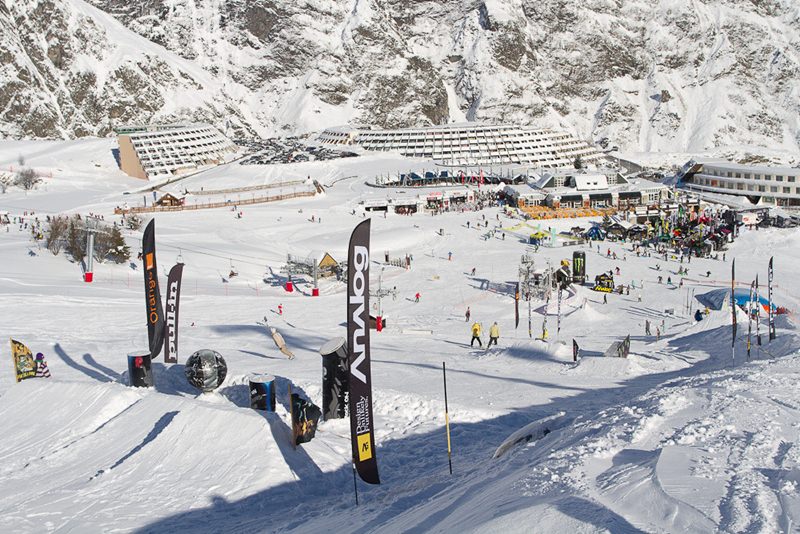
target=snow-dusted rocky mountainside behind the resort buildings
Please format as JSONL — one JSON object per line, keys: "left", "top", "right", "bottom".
{"left": 0, "top": 0, "right": 800, "bottom": 152}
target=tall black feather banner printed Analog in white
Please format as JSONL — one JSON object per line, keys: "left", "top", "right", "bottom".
{"left": 347, "top": 219, "right": 380, "bottom": 484}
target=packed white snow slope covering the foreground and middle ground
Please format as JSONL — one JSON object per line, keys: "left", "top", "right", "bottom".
{"left": 0, "top": 139, "right": 800, "bottom": 533}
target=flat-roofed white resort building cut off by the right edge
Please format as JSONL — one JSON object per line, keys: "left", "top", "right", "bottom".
{"left": 679, "top": 159, "right": 800, "bottom": 208}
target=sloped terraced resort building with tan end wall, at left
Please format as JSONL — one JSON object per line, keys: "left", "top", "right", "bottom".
{"left": 116, "top": 124, "right": 237, "bottom": 180}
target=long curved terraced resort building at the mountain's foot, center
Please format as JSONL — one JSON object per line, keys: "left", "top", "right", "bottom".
{"left": 317, "top": 123, "right": 604, "bottom": 168}
